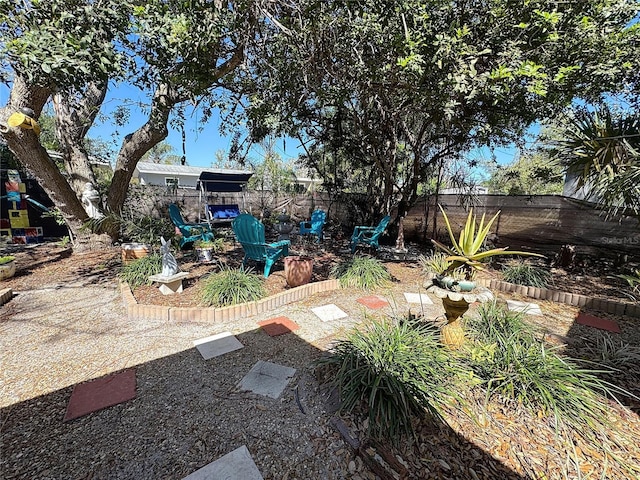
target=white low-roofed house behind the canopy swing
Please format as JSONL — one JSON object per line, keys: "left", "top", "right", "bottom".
{"left": 132, "top": 162, "right": 251, "bottom": 190}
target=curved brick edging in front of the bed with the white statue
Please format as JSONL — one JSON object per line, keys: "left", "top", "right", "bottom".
{"left": 120, "top": 279, "right": 340, "bottom": 323}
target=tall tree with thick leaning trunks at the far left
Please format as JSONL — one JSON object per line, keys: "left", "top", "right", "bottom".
{"left": 0, "top": 0, "right": 271, "bottom": 244}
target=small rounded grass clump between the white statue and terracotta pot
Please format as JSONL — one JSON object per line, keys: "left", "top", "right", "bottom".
{"left": 200, "top": 268, "right": 266, "bottom": 307}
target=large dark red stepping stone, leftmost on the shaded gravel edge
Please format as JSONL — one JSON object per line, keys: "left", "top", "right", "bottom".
{"left": 63, "top": 368, "right": 136, "bottom": 422}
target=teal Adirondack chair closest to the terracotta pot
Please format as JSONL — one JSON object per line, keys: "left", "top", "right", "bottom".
{"left": 231, "top": 213, "right": 291, "bottom": 278}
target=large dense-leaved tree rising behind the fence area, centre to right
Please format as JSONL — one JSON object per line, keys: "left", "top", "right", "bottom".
{"left": 241, "top": 0, "right": 638, "bottom": 222}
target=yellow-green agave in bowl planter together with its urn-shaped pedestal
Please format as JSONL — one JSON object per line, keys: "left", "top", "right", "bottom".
{"left": 431, "top": 205, "right": 542, "bottom": 348}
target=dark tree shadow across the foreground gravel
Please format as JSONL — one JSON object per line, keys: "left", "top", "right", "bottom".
{"left": 0, "top": 328, "right": 524, "bottom": 479}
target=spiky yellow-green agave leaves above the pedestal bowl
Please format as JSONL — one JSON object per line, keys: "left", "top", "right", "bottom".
{"left": 431, "top": 205, "right": 542, "bottom": 280}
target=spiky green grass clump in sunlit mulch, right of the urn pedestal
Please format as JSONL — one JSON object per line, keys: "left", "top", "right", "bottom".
{"left": 468, "top": 302, "right": 620, "bottom": 428}
